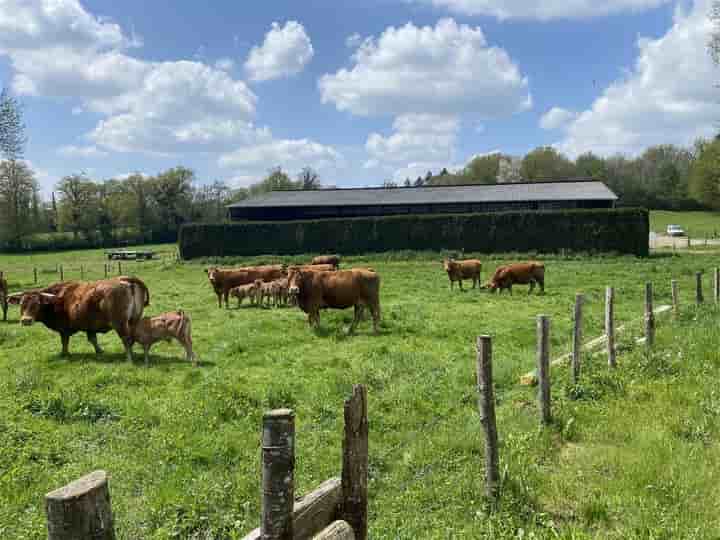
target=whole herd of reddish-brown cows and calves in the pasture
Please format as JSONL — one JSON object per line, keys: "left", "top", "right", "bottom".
{"left": 0, "top": 255, "right": 545, "bottom": 365}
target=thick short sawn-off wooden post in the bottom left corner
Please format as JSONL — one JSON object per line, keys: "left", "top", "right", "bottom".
{"left": 45, "top": 471, "right": 115, "bottom": 540}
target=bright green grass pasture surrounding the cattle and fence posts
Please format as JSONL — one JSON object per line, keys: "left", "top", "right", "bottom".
{"left": 0, "top": 246, "right": 720, "bottom": 539}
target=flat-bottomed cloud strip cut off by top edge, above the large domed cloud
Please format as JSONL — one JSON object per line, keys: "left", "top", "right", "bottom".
{"left": 415, "top": 0, "right": 672, "bottom": 21}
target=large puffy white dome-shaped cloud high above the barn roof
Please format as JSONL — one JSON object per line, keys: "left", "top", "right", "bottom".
{"left": 319, "top": 19, "right": 532, "bottom": 118}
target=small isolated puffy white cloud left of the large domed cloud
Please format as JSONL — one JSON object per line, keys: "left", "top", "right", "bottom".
{"left": 245, "top": 21, "right": 314, "bottom": 81}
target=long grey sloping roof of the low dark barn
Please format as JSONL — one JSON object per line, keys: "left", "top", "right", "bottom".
{"left": 229, "top": 181, "right": 617, "bottom": 208}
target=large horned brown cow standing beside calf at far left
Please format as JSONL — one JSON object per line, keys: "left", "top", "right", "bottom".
{"left": 9, "top": 276, "right": 150, "bottom": 360}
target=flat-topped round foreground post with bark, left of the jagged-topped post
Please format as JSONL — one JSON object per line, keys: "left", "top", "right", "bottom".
{"left": 260, "top": 409, "right": 295, "bottom": 540}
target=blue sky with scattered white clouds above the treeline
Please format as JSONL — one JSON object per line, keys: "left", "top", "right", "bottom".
{"left": 0, "top": 0, "right": 720, "bottom": 195}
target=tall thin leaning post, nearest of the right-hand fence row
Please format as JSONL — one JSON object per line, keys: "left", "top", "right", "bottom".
{"left": 477, "top": 336, "right": 500, "bottom": 502}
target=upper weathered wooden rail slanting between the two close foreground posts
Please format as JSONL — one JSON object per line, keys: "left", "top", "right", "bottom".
{"left": 244, "top": 477, "right": 342, "bottom": 540}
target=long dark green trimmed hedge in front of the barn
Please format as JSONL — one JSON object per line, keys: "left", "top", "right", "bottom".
{"left": 179, "top": 208, "right": 649, "bottom": 259}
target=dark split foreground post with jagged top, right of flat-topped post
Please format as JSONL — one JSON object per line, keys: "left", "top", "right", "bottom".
{"left": 340, "top": 384, "right": 368, "bottom": 540}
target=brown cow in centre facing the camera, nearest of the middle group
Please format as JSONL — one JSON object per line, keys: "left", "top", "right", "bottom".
{"left": 288, "top": 269, "right": 380, "bottom": 334}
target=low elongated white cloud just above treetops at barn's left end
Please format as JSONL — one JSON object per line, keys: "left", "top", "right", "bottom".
{"left": 219, "top": 139, "right": 343, "bottom": 174}
